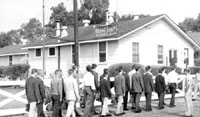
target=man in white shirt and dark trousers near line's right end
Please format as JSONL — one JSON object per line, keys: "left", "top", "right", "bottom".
{"left": 168, "top": 67, "right": 178, "bottom": 107}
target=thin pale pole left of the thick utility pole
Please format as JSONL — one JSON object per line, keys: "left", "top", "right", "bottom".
{"left": 42, "top": 0, "right": 45, "bottom": 79}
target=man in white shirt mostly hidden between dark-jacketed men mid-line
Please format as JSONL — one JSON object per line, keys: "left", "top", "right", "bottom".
{"left": 128, "top": 65, "right": 136, "bottom": 109}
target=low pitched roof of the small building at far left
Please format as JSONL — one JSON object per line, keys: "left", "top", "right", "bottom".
{"left": 0, "top": 45, "right": 28, "bottom": 56}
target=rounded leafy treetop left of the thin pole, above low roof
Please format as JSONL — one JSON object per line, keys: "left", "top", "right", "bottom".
{"left": 20, "top": 18, "right": 43, "bottom": 42}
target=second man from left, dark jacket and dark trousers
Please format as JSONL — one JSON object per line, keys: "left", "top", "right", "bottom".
{"left": 36, "top": 69, "right": 45, "bottom": 117}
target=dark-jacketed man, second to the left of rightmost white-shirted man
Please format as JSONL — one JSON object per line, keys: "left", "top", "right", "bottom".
{"left": 143, "top": 66, "right": 153, "bottom": 111}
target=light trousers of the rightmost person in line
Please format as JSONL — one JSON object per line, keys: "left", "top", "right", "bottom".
{"left": 185, "top": 88, "right": 194, "bottom": 116}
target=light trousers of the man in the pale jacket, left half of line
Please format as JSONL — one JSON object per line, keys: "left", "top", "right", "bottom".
{"left": 66, "top": 100, "right": 76, "bottom": 117}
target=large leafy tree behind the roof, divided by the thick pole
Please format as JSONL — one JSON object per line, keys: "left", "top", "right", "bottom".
{"left": 46, "top": 0, "right": 109, "bottom": 30}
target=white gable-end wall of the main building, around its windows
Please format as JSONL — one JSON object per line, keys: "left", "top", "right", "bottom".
{"left": 117, "top": 20, "right": 194, "bottom": 67}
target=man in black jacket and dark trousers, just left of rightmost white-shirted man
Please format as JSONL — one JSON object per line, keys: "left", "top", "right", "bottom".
{"left": 155, "top": 69, "right": 165, "bottom": 109}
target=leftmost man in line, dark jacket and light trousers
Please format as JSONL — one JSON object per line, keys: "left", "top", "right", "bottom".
{"left": 25, "top": 69, "right": 40, "bottom": 117}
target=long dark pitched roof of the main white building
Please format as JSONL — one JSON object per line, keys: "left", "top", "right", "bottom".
{"left": 24, "top": 15, "right": 163, "bottom": 48}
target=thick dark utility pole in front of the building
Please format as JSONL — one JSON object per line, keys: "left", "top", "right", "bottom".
{"left": 74, "top": 0, "right": 79, "bottom": 70}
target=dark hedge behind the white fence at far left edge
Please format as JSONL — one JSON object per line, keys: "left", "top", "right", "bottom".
{"left": 0, "top": 64, "right": 30, "bottom": 80}
